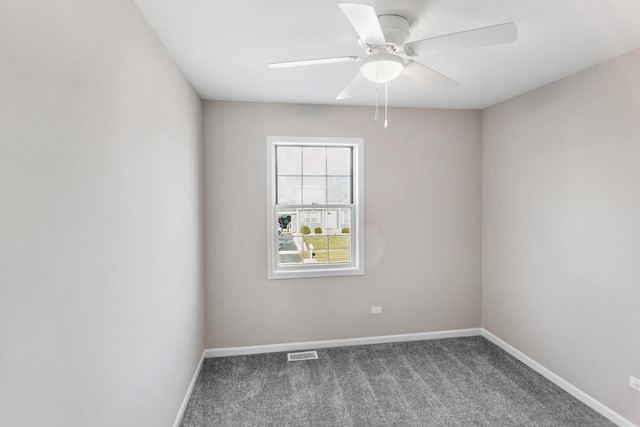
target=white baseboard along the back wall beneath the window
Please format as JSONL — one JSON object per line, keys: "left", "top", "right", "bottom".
{"left": 204, "top": 328, "right": 481, "bottom": 358}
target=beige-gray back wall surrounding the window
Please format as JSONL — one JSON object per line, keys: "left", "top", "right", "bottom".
{"left": 203, "top": 101, "right": 481, "bottom": 348}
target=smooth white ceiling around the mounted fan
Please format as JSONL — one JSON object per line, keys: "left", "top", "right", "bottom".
{"left": 134, "top": 0, "right": 640, "bottom": 109}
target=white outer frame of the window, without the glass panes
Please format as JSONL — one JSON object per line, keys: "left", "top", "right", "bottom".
{"left": 266, "top": 136, "right": 365, "bottom": 280}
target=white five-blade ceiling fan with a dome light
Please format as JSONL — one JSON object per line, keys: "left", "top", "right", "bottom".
{"left": 269, "top": 3, "right": 518, "bottom": 103}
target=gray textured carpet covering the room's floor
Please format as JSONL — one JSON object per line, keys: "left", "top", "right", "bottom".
{"left": 181, "top": 337, "right": 614, "bottom": 427}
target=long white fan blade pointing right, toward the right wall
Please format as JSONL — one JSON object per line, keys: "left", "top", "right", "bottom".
{"left": 404, "top": 22, "right": 518, "bottom": 56}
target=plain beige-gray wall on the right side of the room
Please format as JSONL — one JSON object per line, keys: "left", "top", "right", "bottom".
{"left": 482, "top": 47, "right": 640, "bottom": 424}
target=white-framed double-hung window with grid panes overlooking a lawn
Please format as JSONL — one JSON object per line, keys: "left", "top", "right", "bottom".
{"left": 267, "top": 137, "right": 364, "bottom": 279}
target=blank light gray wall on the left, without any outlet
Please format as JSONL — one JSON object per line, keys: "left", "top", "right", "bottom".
{"left": 0, "top": 0, "right": 203, "bottom": 427}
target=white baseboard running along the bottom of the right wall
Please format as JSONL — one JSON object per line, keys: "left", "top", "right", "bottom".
{"left": 480, "top": 328, "right": 638, "bottom": 427}
